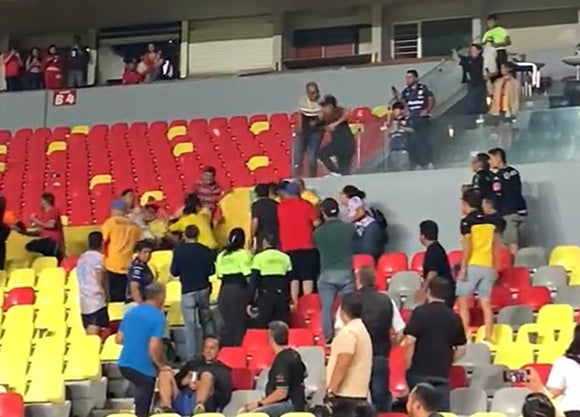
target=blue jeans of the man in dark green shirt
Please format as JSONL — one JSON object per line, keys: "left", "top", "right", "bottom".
{"left": 318, "top": 270, "right": 354, "bottom": 342}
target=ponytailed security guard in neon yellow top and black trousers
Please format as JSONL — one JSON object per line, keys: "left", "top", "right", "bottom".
{"left": 215, "top": 227, "right": 252, "bottom": 346}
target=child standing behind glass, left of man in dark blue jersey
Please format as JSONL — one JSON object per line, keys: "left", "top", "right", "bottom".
{"left": 389, "top": 101, "right": 413, "bottom": 171}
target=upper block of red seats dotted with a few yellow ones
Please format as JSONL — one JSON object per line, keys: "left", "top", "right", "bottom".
{"left": 0, "top": 108, "right": 384, "bottom": 225}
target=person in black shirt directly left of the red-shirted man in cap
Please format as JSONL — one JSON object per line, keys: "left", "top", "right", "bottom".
{"left": 250, "top": 184, "right": 278, "bottom": 250}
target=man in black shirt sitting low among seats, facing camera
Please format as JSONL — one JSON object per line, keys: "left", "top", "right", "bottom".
{"left": 159, "top": 336, "right": 232, "bottom": 416}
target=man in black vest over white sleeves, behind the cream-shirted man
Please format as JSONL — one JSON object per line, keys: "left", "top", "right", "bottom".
{"left": 335, "top": 267, "right": 405, "bottom": 413}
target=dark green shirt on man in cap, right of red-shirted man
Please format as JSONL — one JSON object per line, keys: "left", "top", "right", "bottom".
{"left": 314, "top": 219, "right": 356, "bottom": 271}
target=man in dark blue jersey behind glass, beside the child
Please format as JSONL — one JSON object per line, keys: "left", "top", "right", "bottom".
{"left": 400, "top": 70, "right": 435, "bottom": 169}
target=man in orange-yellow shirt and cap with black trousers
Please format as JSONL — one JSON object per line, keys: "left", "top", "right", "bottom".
{"left": 101, "top": 199, "right": 141, "bottom": 302}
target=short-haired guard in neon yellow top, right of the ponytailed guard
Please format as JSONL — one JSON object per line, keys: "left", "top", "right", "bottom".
{"left": 247, "top": 235, "right": 292, "bottom": 329}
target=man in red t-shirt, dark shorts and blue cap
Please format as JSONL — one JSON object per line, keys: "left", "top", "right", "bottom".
{"left": 278, "top": 183, "right": 320, "bottom": 306}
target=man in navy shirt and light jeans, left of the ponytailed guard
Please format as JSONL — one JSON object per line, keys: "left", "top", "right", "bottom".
{"left": 170, "top": 225, "right": 215, "bottom": 360}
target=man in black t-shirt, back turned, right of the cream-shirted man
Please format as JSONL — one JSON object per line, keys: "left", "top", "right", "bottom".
{"left": 403, "top": 277, "right": 467, "bottom": 411}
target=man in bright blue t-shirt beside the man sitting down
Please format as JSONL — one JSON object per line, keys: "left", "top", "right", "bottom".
{"left": 115, "top": 283, "right": 173, "bottom": 417}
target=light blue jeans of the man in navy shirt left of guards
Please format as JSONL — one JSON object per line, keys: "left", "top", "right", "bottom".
{"left": 181, "top": 288, "right": 213, "bottom": 360}
